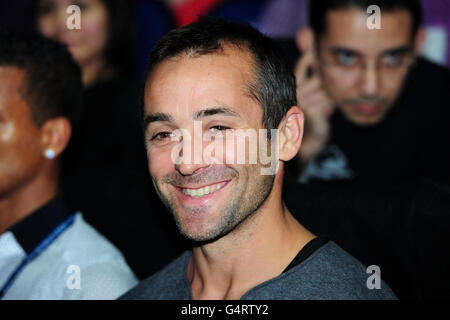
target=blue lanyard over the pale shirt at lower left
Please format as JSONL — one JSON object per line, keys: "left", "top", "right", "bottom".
{"left": 0, "top": 214, "right": 75, "bottom": 299}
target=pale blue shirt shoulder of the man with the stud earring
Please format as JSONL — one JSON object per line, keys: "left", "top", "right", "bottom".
{"left": 6, "top": 214, "right": 137, "bottom": 300}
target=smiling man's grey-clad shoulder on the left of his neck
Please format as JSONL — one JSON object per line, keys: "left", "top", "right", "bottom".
{"left": 120, "top": 251, "right": 191, "bottom": 300}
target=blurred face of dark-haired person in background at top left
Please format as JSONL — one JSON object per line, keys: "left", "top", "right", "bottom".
{"left": 37, "top": 0, "right": 109, "bottom": 76}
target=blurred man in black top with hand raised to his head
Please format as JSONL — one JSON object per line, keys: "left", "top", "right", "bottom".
{"left": 285, "top": 0, "right": 450, "bottom": 299}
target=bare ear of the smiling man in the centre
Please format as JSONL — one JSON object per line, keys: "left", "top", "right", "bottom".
{"left": 278, "top": 106, "right": 305, "bottom": 161}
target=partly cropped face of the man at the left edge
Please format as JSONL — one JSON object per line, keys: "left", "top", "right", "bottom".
{"left": 0, "top": 66, "right": 42, "bottom": 199}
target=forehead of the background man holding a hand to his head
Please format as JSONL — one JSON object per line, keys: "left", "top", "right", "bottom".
{"left": 320, "top": 8, "right": 412, "bottom": 54}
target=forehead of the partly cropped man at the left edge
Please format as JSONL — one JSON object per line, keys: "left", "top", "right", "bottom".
{"left": 0, "top": 66, "right": 29, "bottom": 115}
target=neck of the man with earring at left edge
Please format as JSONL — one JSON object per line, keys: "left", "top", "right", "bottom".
{"left": 0, "top": 170, "right": 58, "bottom": 235}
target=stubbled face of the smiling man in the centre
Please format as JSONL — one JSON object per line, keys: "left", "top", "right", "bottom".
{"left": 145, "top": 46, "right": 274, "bottom": 241}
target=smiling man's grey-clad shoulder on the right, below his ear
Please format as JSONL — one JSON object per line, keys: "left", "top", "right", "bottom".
{"left": 244, "top": 241, "right": 396, "bottom": 300}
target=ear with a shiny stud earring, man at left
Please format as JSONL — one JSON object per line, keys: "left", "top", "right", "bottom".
{"left": 41, "top": 117, "right": 72, "bottom": 159}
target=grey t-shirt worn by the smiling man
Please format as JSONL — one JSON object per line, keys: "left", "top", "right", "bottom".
{"left": 120, "top": 241, "right": 396, "bottom": 300}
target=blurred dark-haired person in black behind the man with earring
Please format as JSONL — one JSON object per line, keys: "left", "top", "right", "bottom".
{"left": 32, "top": 0, "right": 187, "bottom": 279}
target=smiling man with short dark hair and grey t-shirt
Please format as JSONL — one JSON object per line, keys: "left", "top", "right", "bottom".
{"left": 122, "top": 19, "right": 395, "bottom": 299}
